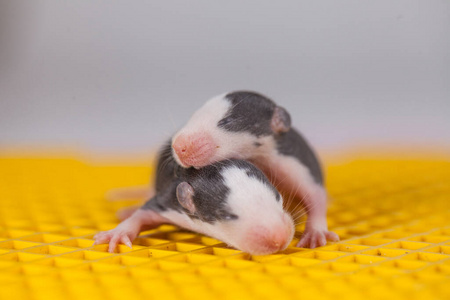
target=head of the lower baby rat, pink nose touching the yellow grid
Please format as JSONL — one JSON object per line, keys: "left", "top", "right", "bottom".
{"left": 177, "top": 160, "right": 294, "bottom": 255}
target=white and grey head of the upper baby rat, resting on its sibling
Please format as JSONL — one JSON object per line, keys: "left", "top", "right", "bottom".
{"left": 172, "top": 91, "right": 291, "bottom": 168}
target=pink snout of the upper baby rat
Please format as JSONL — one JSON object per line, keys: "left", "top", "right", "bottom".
{"left": 172, "top": 132, "right": 216, "bottom": 168}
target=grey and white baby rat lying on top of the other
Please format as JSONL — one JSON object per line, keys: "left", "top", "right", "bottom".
{"left": 172, "top": 91, "right": 339, "bottom": 248}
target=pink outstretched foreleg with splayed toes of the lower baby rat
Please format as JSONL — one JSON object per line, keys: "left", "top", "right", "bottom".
{"left": 94, "top": 209, "right": 169, "bottom": 253}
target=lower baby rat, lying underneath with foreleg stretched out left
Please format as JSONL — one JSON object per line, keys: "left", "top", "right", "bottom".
{"left": 94, "top": 143, "right": 295, "bottom": 255}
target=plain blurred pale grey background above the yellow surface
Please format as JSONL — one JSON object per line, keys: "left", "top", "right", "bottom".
{"left": 0, "top": 0, "right": 450, "bottom": 157}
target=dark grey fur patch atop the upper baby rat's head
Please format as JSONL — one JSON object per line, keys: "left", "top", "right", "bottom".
{"left": 217, "top": 91, "right": 276, "bottom": 137}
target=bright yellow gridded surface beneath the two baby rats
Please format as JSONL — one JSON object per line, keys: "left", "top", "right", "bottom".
{"left": 0, "top": 157, "right": 450, "bottom": 299}
